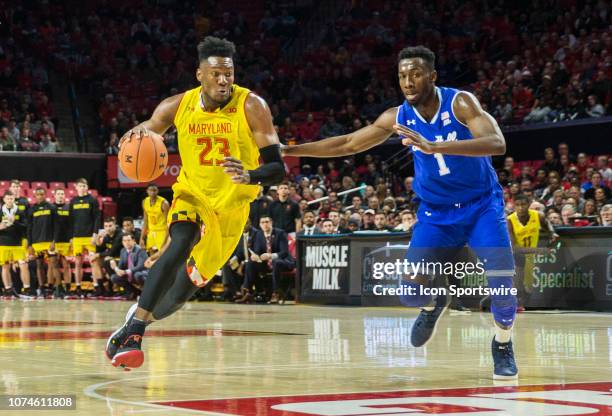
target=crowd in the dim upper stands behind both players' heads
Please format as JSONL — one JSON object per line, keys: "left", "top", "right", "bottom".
{"left": 0, "top": 0, "right": 612, "bottom": 154}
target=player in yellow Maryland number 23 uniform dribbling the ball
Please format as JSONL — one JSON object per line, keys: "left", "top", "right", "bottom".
{"left": 106, "top": 36, "right": 285, "bottom": 369}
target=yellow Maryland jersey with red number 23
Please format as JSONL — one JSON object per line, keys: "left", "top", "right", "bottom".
{"left": 174, "top": 84, "right": 260, "bottom": 212}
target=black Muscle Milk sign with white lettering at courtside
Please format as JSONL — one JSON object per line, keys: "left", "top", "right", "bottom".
{"left": 302, "top": 240, "right": 350, "bottom": 294}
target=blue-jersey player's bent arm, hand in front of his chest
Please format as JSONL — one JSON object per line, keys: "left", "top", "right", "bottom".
{"left": 395, "top": 91, "right": 506, "bottom": 156}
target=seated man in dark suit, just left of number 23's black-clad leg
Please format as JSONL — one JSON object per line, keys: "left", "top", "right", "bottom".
{"left": 110, "top": 234, "right": 148, "bottom": 300}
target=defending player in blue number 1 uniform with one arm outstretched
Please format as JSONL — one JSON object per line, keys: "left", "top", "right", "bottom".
{"left": 283, "top": 46, "right": 518, "bottom": 379}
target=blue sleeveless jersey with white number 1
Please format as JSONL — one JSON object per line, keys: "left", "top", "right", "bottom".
{"left": 397, "top": 87, "right": 500, "bottom": 205}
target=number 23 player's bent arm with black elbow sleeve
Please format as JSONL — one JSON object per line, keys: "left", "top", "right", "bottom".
{"left": 223, "top": 93, "right": 285, "bottom": 186}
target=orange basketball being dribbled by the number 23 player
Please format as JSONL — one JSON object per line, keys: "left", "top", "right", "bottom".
{"left": 119, "top": 134, "right": 168, "bottom": 182}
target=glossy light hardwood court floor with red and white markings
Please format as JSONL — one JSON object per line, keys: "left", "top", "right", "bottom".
{"left": 0, "top": 300, "right": 612, "bottom": 416}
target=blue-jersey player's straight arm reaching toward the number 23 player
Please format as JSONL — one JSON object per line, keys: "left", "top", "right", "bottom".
{"left": 283, "top": 107, "right": 397, "bottom": 157}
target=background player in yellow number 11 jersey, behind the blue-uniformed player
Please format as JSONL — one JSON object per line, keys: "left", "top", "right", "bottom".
{"left": 507, "top": 195, "right": 559, "bottom": 304}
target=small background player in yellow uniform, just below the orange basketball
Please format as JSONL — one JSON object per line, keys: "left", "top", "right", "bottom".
{"left": 140, "top": 184, "right": 170, "bottom": 251}
